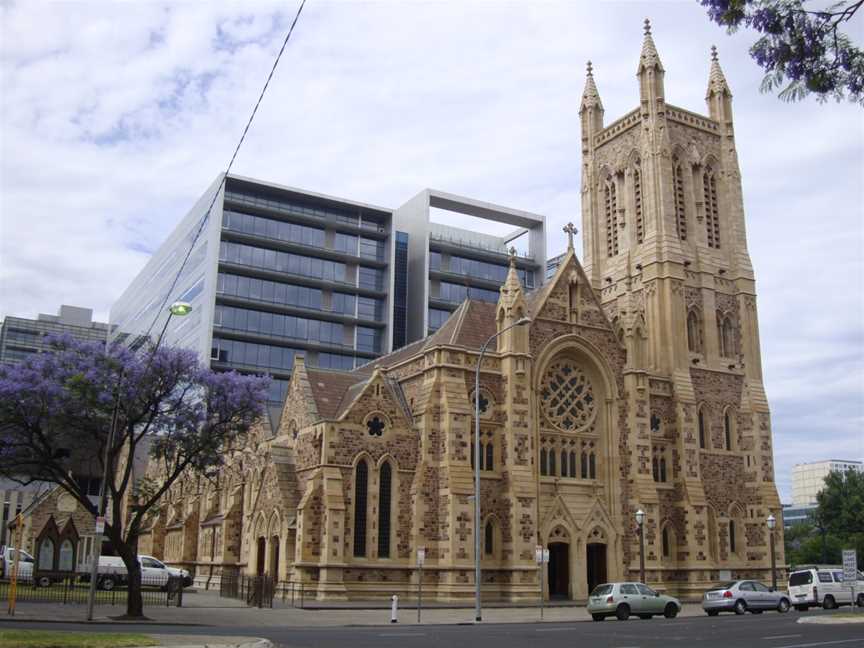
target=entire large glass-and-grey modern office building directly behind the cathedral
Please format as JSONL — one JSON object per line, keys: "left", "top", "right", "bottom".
{"left": 110, "top": 175, "right": 545, "bottom": 412}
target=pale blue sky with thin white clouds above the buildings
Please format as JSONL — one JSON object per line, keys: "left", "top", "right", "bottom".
{"left": 0, "top": 0, "right": 864, "bottom": 501}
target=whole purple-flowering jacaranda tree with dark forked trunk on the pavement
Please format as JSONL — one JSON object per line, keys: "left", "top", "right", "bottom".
{"left": 0, "top": 337, "right": 269, "bottom": 617}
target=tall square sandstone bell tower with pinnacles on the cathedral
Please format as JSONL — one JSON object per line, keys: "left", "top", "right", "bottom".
{"left": 579, "top": 20, "right": 780, "bottom": 592}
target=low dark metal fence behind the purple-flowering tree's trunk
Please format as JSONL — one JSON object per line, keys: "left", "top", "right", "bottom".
{"left": 0, "top": 573, "right": 183, "bottom": 607}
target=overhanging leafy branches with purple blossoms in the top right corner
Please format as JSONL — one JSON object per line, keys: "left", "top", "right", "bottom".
{"left": 699, "top": 0, "right": 864, "bottom": 104}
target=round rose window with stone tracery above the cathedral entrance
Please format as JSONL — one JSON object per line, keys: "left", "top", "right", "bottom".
{"left": 540, "top": 359, "right": 596, "bottom": 432}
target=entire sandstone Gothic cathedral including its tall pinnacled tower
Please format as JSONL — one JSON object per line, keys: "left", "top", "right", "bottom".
{"left": 25, "top": 24, "right": 784, "bottom": 601}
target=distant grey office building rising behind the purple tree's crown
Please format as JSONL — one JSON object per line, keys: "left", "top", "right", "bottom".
{"left": 0, "top": 304, "right": 108, "bottom": 364}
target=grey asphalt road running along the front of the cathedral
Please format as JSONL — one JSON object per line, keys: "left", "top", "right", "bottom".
{"left": 0, "top": 612, "right": 864, "bottom": 648}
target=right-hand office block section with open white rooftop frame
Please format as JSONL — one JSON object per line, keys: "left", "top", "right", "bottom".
{"left": 393, "top": 189, "right": 546, "bottom": 340}
